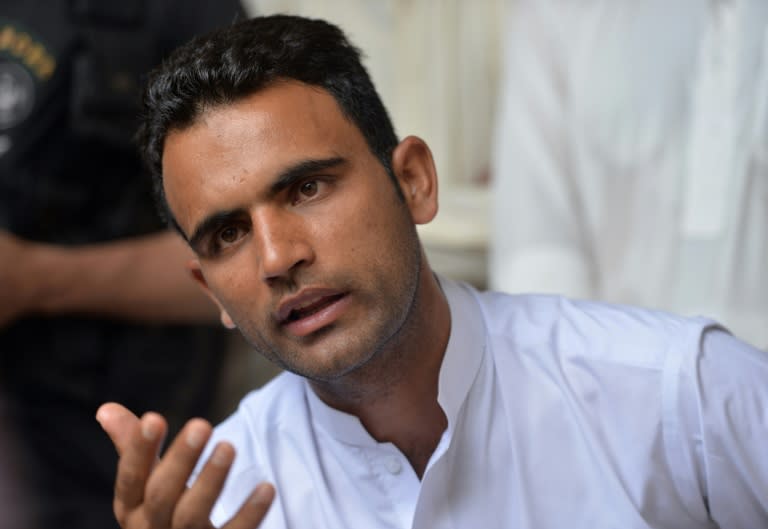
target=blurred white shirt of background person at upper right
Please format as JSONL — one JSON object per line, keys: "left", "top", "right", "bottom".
{"left": 490, "top": 0, "right": 768, "bottom": 348}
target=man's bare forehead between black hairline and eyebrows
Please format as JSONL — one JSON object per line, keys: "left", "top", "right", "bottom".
{"left": 163, "top": 81, "right": 372, "bottom": 231}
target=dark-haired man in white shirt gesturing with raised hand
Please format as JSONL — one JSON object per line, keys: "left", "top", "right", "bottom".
{"left": 97, "top": 16, "right": 768, "bottom": 529}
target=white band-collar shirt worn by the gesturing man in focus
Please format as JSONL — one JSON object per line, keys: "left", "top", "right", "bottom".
{"left": 198, "top": 280, "right": 768, "bottom": 529}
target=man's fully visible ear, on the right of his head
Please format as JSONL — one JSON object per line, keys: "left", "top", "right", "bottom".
{"left": 392, "top": 136, "right": 437, "bottom": 224}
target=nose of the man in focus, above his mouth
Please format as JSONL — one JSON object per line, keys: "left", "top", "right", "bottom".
{"left": 252, "top": 208, "right": 314, "bottom": 283}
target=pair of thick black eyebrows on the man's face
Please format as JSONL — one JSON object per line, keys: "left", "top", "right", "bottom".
{"left": 182, "top": 156, "right": 347, "bottom": 253}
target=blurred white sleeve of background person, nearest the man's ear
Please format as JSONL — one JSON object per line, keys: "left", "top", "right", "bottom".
{"left": 489, "top": 0, "right": 595, "bottom": 298}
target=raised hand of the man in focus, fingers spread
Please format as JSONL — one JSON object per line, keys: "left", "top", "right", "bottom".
{"left": 96, "top": 403, "right": 274, "bottom": 529}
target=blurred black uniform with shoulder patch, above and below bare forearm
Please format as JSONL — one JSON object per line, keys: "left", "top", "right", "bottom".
{"left": 0, "top": 0, "right": 243, "bottom": 529}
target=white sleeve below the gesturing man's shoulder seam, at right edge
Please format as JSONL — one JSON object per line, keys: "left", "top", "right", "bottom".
{"left": 665, "top": 328, "right": 768, "bottom": 529}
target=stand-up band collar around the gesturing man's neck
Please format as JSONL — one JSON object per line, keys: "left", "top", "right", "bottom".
{"left": 305, "top": 276, "right": 486, "bottom": 446}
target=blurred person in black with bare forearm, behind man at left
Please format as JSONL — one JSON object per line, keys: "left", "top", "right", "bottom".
{"left": 0, "top": 0, "right": 243, "bottom": 529}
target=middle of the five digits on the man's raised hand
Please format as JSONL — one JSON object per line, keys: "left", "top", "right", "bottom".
{"left": 144, "top": 419, "right": 212, "bottom": 527}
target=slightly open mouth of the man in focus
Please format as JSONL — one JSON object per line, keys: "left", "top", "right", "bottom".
{"left": 278, "top": 290, "right": 349, "bottom": 337}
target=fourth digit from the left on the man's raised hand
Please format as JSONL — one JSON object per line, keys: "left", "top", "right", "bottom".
{"left": 172, "top": 443, "right": 235, "bottom": 527}
